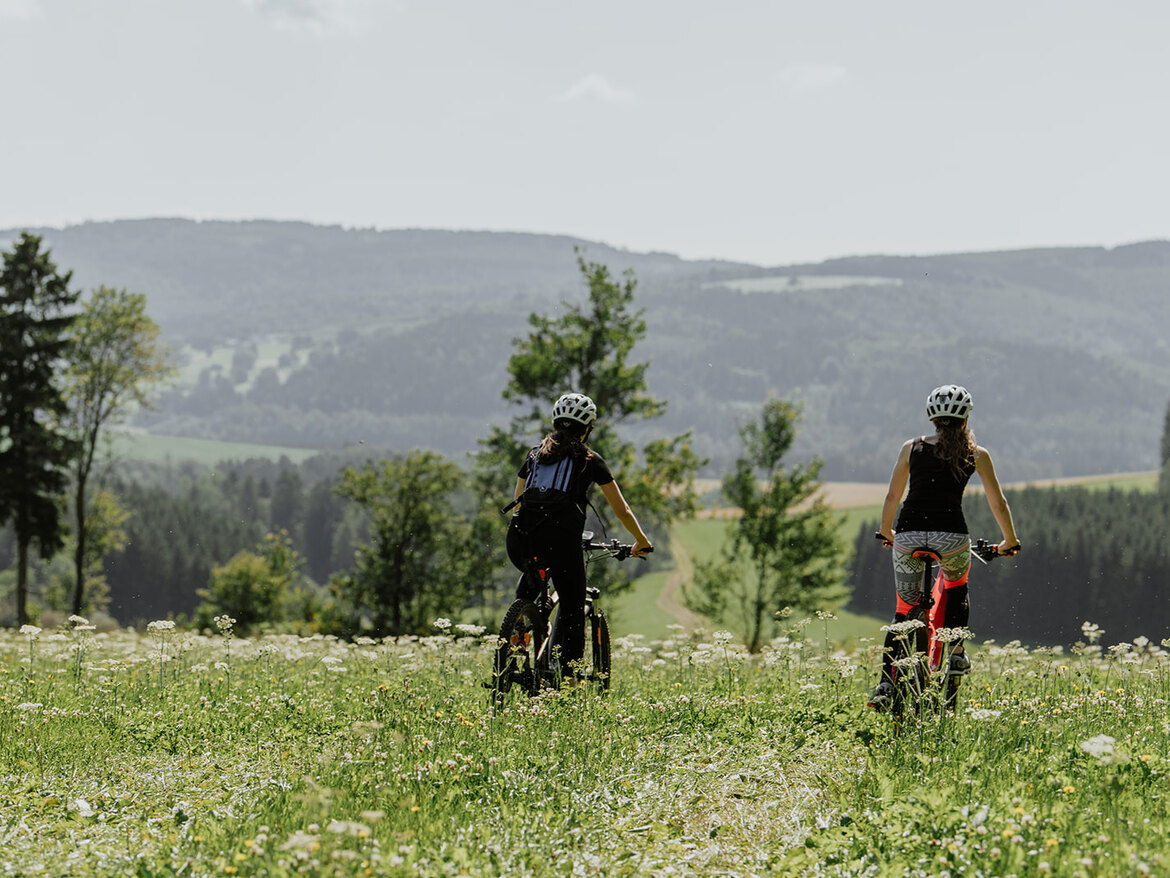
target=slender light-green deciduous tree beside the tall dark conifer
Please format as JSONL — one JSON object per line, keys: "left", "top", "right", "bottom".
{"left": 63, "top": 287, "right": 173, "bottom": 615}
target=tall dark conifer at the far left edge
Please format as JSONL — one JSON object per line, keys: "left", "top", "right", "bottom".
{"left": 0, "top": 232, "right": 78, "bottom": 625}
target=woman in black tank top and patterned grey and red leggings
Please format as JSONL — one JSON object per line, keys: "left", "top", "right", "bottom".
{"left": 868, "top": 384, "right": 1019, "bottom": 709}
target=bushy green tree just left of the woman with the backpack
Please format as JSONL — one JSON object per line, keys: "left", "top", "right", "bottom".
{"left": 330, "top": 451, "right": 468, "bottom": 637}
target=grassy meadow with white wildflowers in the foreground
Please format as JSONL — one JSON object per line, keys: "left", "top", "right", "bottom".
{"left": 0, "top": 622, "right": 1170, "bottom": 876}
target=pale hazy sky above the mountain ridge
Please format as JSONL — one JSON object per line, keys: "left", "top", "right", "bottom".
{"left": 0, "top": 0, "right": 1170, "bottom": 265}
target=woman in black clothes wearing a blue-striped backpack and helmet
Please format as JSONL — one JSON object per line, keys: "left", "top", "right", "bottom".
{"left": 507, "top": 393, "right": 652, "bottom": 668}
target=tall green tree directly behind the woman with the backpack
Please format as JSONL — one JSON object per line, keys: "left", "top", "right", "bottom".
{"left": 476, "top": 252, "right": 706, "bottom": 599}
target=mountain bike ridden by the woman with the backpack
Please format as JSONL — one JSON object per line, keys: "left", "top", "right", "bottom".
{"left": 484, "top": 530, "right": 653, "bottom": 705}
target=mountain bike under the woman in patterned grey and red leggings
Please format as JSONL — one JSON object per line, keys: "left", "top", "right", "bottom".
{"left": 869, "top": 533, "right": 1020, "bottom": 718}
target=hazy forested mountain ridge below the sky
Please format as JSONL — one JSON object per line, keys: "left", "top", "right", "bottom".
{"left": 0, "top": 219, "right": 1170, "bottom": 481}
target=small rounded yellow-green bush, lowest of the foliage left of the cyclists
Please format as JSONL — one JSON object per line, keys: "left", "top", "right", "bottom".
{"left": 194, "top": 533, "right": 303, "bottom": 636}
